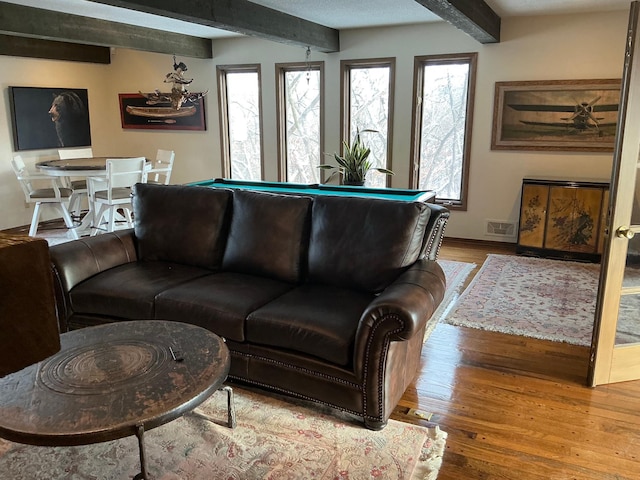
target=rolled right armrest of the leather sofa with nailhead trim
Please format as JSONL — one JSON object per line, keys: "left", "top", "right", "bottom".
{"left": 354, "top": 259, "right": 446, "bottom": 376}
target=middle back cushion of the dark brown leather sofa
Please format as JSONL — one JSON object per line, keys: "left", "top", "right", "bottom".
{"left": 222, "top": 190, "right": 311, "bottom": 283}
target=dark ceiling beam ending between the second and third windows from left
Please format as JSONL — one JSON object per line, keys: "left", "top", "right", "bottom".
{"left": 91, "top": 0, "right": 340, "bottom": 52}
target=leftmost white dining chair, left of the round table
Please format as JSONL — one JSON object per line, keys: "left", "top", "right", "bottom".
{"left": 11, "top": 155, "right": 78, "bottom": 239}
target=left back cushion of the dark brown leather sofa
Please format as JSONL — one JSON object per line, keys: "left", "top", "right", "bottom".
{"left": 133, "top": 183, "right": 232, "bottom": 269}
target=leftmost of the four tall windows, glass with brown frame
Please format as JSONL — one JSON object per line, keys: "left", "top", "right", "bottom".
{"left": 218, "top": 65, "right": 264, "bottom": 180}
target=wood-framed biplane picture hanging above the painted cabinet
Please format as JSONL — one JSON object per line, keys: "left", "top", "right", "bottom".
{"left": 491, "top": 79, "right": 621, "bottom": 152}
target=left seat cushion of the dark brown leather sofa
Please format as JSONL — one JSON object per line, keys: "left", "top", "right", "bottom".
{"left": 69, "top": 262, "right": 211, "bottom": 319}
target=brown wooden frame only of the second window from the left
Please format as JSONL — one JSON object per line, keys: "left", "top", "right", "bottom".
{"left": 275, "top": 61, "right": 325, "bottom": 183}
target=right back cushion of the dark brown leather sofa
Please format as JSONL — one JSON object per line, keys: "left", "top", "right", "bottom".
{"left": 309, "top": 196, "right": 431, "bottom": 292}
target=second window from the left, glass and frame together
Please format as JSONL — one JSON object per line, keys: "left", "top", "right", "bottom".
{"left": 276, "top": 62, "right": 324, "bottom": 183}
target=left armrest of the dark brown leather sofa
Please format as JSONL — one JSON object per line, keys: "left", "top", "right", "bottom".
{"left": 49, "top": 229, "right": 138, "bottom": 332}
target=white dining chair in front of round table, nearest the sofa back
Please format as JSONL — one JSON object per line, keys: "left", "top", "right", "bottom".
{"left": 87, "top": 157, "right": 146, "bottom": 235}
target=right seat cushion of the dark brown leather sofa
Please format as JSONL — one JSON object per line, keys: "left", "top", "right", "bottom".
{"left": 246, "top": 284, "right": 374, "bottom": 366}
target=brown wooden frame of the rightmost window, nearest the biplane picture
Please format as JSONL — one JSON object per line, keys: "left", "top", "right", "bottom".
{"left": 409, "top": 52, "right": 478, "bottom": 211}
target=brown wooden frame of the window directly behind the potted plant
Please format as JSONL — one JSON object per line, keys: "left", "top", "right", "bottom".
{"left": 340, "top": 57, "right": 396, "bottom": 187}
